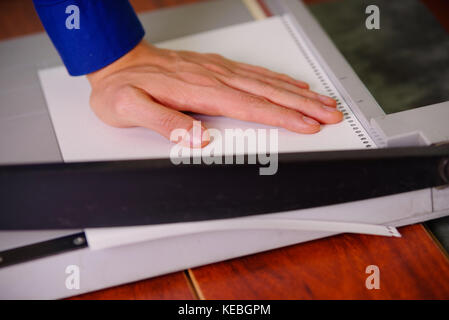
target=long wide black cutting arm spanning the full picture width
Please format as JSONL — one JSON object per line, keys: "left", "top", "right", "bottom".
{"left": 0, "top": 145, "right": 449, "bottom": 230}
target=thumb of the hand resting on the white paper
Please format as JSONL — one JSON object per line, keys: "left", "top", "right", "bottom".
{"left": 114, "top": 87, "right": 210, "bottom": 148}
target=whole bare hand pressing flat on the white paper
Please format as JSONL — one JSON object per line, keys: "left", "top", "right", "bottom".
{"left": 87, "top": 41, "right": 343, "bottom": 146}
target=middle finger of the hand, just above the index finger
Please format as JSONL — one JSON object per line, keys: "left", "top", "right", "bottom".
{"left": 218, "top": 75, "right": 343, "bottom": 124}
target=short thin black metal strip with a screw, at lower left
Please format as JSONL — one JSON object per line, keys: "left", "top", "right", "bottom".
{"left": 0, "top": 232, "right": 88, "bottom": 268}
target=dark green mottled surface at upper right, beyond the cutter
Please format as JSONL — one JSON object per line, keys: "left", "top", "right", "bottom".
{"left": 309, "top": 0, "right": 449, "bottom": 113}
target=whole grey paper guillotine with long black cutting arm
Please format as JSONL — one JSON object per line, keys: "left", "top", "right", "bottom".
{"left": 0, "top": 0, "right": 449, "bottom": 299}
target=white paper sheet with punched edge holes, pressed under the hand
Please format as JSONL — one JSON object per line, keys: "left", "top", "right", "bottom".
{"left": 39, "top": 17, "right": 375, "bottom": 162}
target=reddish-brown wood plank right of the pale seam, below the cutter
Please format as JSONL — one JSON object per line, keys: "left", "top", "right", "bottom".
{"left": 190, "top": 225, "right": 449, "bottom": 299}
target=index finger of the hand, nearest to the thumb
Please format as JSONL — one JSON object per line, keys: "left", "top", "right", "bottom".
{"left": 203, "top": 86, "right": 320, "bottom": 134}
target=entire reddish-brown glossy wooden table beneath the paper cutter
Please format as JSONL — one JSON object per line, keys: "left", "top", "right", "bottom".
{"left": 0, "top": 0, "right": 449, "bottom": 299}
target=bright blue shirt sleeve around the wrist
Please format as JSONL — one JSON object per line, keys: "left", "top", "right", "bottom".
{"left": 33, "top": 0, "right": 145, "bottom": 76}
